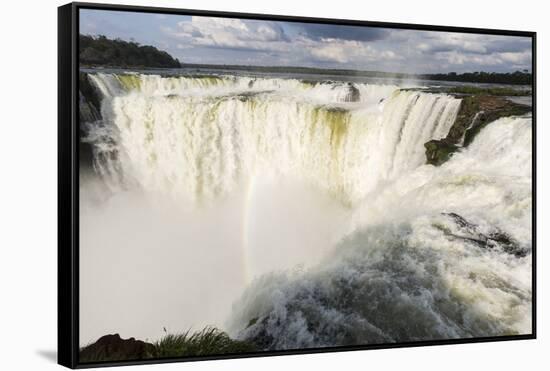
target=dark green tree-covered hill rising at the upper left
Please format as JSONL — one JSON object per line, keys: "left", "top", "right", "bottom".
{"left": 79, "top": 35, "right": 180, "bottom": 68}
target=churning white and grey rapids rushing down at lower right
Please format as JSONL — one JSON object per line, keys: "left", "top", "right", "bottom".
{"left": 230, "top": 117, "right": 532, "bottom": 349}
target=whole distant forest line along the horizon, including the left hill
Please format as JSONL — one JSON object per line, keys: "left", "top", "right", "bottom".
{"left": 79, "top": 35, "right": 533, "bottom": 85}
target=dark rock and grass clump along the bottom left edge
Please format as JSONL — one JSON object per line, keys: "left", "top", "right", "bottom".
{"left": 79, "top": 327, "right": 258, "bottom": 363}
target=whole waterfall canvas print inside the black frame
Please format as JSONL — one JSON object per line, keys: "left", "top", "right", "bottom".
{"left": 78, "top": 9, "right": 533, "bottom": 363}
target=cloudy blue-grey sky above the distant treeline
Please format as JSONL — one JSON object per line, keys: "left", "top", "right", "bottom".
{"left": 80, "top": 9, "right": 532, "bottom": 73}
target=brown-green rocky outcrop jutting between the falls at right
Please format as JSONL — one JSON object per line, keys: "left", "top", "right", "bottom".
{"left": 424, "top": 95, "right": 531, "bottom": 166}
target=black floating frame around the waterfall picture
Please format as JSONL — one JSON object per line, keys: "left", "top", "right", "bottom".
{"left": 58, "top": 2, "right": 537, "bottom": 368}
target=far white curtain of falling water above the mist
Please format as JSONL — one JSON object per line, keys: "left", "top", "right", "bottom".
{"left": 85, "top": 74, "right": 460, "bottom": 204}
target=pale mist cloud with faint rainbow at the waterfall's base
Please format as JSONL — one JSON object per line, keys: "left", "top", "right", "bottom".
{"left": 80, "top": 176, "right": 347, "bottom": 345}
